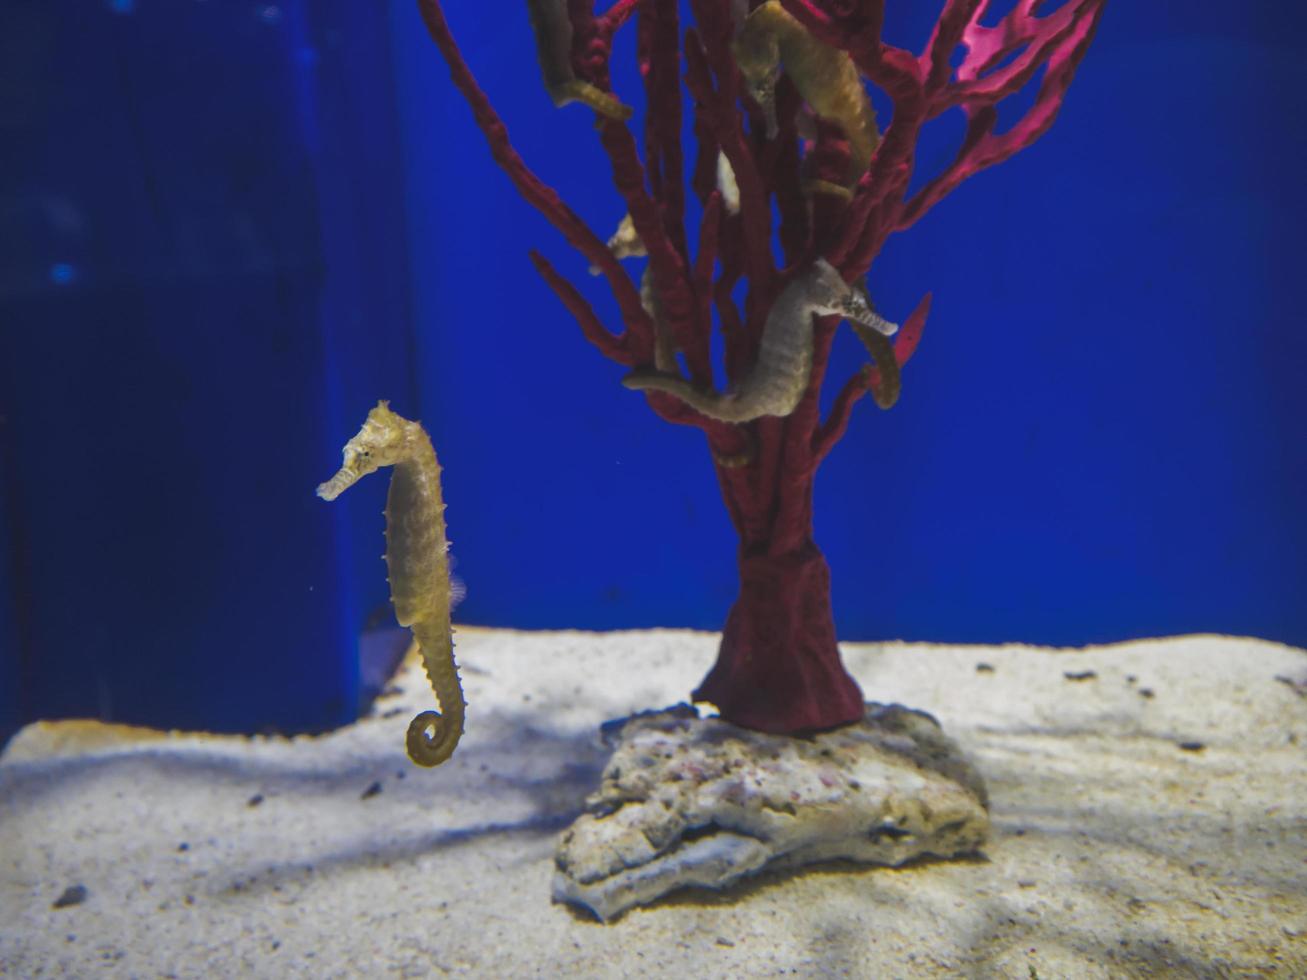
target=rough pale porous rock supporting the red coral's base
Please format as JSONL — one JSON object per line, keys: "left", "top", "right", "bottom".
{"left": 553, "top": 704, "right": 989, "bottom": 921}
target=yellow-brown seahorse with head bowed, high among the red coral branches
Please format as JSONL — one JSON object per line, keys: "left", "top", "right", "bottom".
{"left": 731, "top": 0, "right": 881, "bottom": 196}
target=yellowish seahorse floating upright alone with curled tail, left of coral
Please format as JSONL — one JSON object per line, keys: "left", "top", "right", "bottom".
{"left": 318, "top": 401, "right": 467, "bottom": 766}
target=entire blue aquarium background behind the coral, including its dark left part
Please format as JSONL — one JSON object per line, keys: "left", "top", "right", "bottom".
{"left": 0, "top": 0, "right": 1307, "bottom": 737}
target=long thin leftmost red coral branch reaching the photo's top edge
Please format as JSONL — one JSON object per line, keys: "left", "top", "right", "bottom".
{"left": 418, "top": 0, "right": 654, "bottom": 350}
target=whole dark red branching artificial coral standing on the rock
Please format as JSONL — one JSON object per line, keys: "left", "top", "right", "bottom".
{"left": 418, "top": 0, "right": 1106, "bottom": 733}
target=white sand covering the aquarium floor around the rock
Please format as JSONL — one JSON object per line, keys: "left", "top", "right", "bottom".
{"left": 0, "top": 630, "right": 1307, "bottom": 979}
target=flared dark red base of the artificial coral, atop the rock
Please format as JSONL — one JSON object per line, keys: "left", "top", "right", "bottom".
{"left": 694, "top": 540, "right": 864, "bottom": 733}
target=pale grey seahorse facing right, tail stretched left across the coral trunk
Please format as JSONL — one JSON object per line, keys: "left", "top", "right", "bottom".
{"left": 622, "top": 259, "right": 898, "bottom": 422}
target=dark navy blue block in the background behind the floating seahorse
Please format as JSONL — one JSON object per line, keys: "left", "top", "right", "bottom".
{"left": 0, "top": 0, "right": 416, "bottom": 732}
